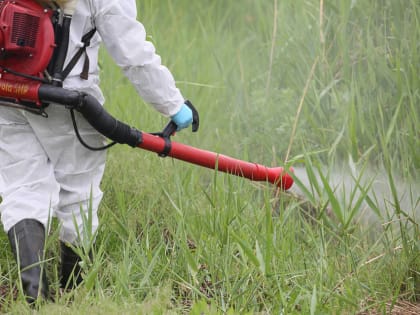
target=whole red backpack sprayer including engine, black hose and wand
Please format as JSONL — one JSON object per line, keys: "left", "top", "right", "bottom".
{"left": 0, "top": 0, "right": 293, "bottom": 190}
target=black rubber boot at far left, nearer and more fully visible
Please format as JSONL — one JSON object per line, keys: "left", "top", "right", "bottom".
{"left": 7, "top": 219, "right": 48, "bottom": 304}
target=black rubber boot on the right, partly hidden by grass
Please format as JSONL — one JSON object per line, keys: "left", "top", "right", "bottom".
{"left": 60, "top": 242, "right": 87, "bottom": 289}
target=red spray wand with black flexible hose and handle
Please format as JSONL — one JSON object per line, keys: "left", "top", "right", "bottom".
{"left": 38, "top": 84, "right": 293, "bottom": 190}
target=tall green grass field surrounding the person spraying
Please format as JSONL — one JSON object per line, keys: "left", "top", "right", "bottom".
{"left": 0, "top": 0, "right": 420, "bottom": 314}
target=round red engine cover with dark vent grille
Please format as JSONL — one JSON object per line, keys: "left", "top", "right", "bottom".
{"left": 0, "top": 0, "right": 55, "bottom": 81}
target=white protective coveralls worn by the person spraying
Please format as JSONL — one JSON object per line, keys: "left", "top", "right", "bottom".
{"left": 0, "top": 0, "right": 184, "bottom": 243}
